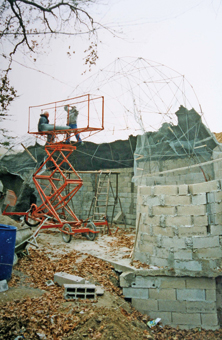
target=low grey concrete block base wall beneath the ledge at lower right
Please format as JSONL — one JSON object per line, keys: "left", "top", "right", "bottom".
{"left": 120, "top": 271, "right": 221, "bottom": 330}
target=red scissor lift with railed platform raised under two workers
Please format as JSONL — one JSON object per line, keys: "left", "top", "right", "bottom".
{"left": 3, "top": 94, "right": 108, "bottom": 242}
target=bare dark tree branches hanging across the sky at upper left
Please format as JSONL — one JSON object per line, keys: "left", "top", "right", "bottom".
{"left": 0, "top": 0, "right": 114, "bottom": 110}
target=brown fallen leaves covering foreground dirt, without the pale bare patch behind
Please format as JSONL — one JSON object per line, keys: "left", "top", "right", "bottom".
{"left": 0, "top": 240, "right": 222, "bottom": 340}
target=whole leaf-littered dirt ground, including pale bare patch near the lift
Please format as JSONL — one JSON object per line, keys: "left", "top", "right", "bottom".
{"left": 0, "top": 216, "right": 222, "bottom": 340}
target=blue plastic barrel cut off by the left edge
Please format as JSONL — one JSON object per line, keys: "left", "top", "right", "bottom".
{"left": 0, "top": 224, "right": 17, "bottom": 281}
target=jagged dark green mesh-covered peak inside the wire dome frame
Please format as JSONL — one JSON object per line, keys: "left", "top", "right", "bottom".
{"left": 135, "top": 106, "right": 218, "bottom": 162}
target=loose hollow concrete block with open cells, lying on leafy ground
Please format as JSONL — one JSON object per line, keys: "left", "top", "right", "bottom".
{"left": 64, "top": 284, "right": 96, "bottom": 300}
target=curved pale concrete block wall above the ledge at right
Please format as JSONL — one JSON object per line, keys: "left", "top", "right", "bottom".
{"left": 135, "top": 180, "right": 222, "bottom": 276}
